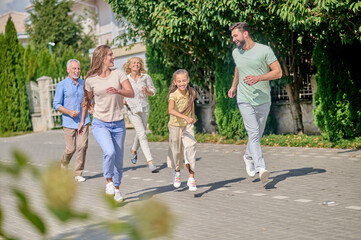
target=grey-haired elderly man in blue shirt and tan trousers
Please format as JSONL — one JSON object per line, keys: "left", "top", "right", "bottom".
{"left": 53, "top": 59, "right": 90, "bottom": 182}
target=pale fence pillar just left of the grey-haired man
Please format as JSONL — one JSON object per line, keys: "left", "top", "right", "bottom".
{"left": 37, "top": 76, "right": 54, "bottom": 131}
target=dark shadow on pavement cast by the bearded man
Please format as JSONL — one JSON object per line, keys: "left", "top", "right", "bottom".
{"left": 262, "top": 167, "right": 326, "bottom": 189}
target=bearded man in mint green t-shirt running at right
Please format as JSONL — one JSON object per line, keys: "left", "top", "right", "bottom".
{"left": 228, "top": 22, "right": 282, "bottom": 183}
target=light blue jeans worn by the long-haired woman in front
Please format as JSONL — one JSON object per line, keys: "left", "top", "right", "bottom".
{"left": 92, "top": 118, "right": 125, "bottom": 187}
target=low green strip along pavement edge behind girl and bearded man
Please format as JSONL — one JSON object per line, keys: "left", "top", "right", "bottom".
{"left": 147, "top": 133, "right": 361, "bottom": 149}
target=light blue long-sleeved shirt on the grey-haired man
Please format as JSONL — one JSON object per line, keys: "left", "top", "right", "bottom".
{"left": 53, "top": 77, "right": 90, "bottom": 129}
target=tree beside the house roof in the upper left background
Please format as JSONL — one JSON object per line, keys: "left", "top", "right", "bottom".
{"left": 26, "top": 0, "right": 95, "bottom": 56}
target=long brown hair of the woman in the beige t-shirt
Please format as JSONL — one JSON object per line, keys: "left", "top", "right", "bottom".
{"left": 82, "top": 45, "right": 111, "bottom": 107}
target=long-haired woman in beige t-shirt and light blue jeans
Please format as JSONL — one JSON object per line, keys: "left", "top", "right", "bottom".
{"left": 78, "top": 45, "right": 134, "bottom": 202}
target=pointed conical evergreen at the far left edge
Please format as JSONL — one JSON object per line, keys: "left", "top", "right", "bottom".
{"left": 0, "top": 17, "right": 31, "bottom": 133}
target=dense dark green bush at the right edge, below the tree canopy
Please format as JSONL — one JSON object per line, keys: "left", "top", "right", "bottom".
{"left": 314, "top": 40, "right": 361, "bottom": 141}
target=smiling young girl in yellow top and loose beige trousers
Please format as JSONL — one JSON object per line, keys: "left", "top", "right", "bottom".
{"left": 167, "top": 69, "right": 197, "bottom": 191}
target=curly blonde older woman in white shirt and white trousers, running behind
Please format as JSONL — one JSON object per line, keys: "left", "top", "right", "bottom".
{"left": 123, "top": 57, "right": 158, "bottom": 172}
